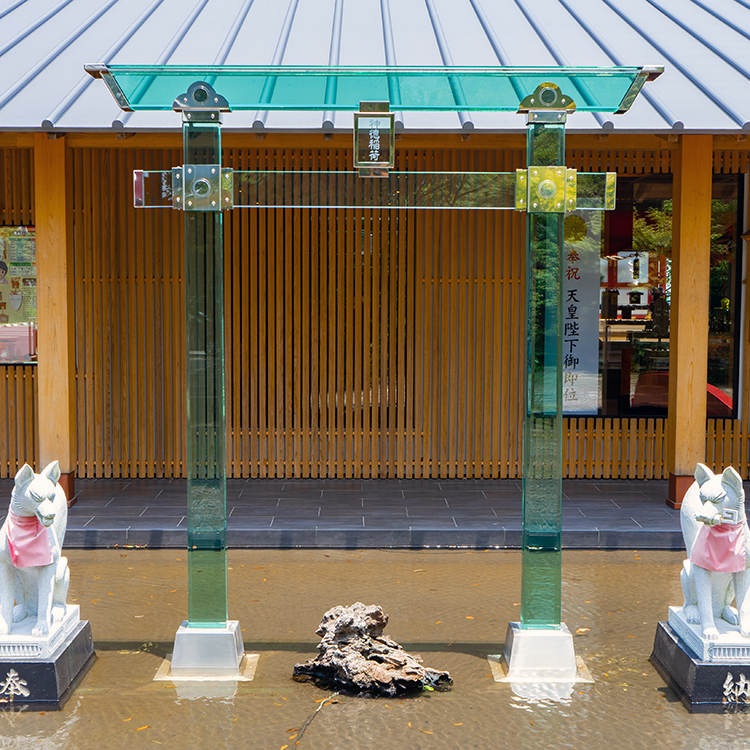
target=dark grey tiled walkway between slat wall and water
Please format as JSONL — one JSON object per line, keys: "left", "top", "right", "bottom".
{"left": 0, "top": 479, "right": 683, "bottom": 549}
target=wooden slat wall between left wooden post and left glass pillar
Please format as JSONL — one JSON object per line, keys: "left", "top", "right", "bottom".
{"left": 73, "top": 149, "right": 185, "bottom": 477}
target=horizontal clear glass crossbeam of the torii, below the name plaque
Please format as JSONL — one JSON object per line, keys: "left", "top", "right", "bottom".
{"left": 134, "top": 170, "right": 607, "bottom": 211}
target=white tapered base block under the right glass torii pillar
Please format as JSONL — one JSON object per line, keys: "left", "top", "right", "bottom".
{"left": 487, "top": 622, "right": 593, "bottom": 700}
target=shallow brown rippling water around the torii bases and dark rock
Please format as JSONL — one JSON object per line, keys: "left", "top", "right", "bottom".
{"left": 0, "top": 549, "right": 750, "bottom": 750}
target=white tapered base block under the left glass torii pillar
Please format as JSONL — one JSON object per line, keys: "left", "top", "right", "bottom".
{"left": 170, "top": 620, "right": 245, "bottom": 679}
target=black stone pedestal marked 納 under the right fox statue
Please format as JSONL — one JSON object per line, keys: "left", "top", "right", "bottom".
{"left": 651, "top": 622, "right": 750, "bottom": 714}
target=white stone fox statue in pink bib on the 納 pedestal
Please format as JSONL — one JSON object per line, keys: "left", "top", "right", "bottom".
{"left": 680, "top": 464, "right": 750, "bottom": 640}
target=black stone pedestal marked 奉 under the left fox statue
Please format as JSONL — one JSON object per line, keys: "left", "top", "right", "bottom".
{"left": 0, "top": 620, "right": 96, "bottom": 711}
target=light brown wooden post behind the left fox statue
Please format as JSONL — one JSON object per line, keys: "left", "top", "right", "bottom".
{"left": 34, "top": 133, "right": 77, "bottom": 502}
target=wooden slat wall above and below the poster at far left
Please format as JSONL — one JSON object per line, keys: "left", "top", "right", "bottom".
{"left": 0, "top": 148, "right": 39, "bottom": 478}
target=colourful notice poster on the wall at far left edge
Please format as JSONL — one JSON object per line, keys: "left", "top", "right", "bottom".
{"left": 0, "top": 227, "right": 37, "bottom": 364}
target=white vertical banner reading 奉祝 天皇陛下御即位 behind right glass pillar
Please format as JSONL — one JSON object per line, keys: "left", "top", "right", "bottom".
{"left": 562, "top": 211, "right": 602, "bottom": 414}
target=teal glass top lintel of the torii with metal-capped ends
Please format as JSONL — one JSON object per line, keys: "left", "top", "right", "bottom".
{"left": 86, "top": 65, "right": 661, "bottom": 114}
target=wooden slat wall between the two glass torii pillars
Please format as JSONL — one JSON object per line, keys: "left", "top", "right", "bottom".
{"left": 225, "top": 150, "right": 523, "bottom": 477}
